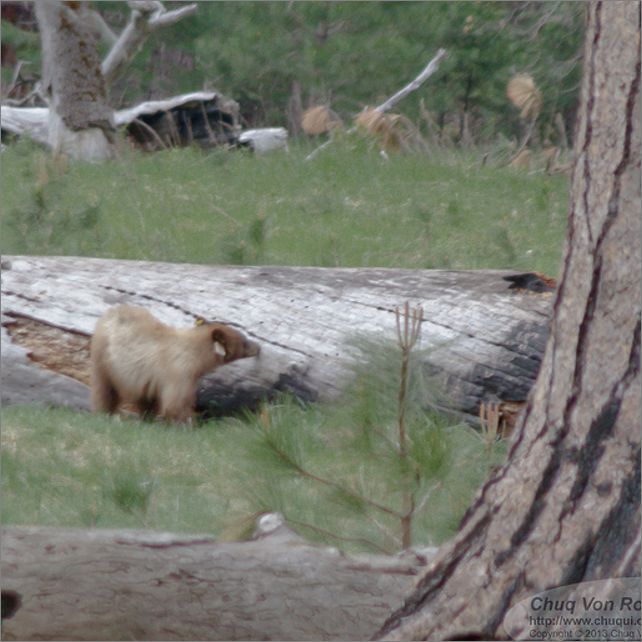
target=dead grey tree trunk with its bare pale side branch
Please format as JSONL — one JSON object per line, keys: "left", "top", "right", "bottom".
{"left": 31, "top": 0, "right": 197, "bottom": 161}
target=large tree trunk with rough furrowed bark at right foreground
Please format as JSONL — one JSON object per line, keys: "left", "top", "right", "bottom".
{"left": 372, "top": 2, "right": 641, "bottom": 640}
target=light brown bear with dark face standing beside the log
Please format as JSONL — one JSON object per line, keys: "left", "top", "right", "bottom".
{"left": 90, "top": 305, "right": 260, "bottom": 423}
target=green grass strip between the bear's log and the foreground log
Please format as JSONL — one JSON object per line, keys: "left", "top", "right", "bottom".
{"left": 1, "top": 344, "right": 505, "bottom": 552}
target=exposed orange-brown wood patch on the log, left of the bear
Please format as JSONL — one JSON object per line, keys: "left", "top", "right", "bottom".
{"left": 3, "top": 316, "right": 90, "bottom": 385}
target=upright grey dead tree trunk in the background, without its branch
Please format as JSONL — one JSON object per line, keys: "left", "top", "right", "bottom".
{"left": 36, "top": 0, "right": 115, "bottom": 161}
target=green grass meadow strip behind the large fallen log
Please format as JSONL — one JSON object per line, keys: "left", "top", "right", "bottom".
{"left": 1, "top": 139, "right": 568, "bottom": 275}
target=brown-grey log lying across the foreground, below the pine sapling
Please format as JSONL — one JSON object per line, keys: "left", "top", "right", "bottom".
{"left": 2, "top": 527, "right": 427, "bottom": 640}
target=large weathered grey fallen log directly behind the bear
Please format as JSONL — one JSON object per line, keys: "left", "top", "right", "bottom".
{"left": 2, "top": 257, "right": 552, "bottom": 422}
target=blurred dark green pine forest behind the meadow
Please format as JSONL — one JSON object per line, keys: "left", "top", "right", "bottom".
{"left": 2, "top": 1, "right": 584, "bottom": 144}
